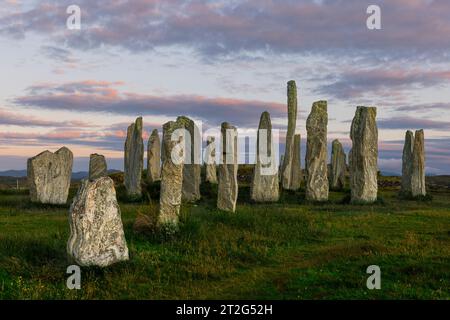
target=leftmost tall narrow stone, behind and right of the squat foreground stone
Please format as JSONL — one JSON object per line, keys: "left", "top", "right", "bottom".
{"left": 124, "top": 117, "right": 144, "bottom": 198}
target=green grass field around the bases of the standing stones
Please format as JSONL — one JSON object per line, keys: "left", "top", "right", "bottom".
{"left": 0, "top": 175, "right": 450, "bottom": 299}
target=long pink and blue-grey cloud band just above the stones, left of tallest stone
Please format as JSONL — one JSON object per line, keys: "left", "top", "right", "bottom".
{"left": 14, "top": 81, "right": 286, "bottom": 126}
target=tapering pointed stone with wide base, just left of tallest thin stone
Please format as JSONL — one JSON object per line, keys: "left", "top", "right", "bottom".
{"left": 250, "top": 112, "right": 279, "bottom": 202}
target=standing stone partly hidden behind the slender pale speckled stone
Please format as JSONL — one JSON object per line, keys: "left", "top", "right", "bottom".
{"left": 177, "top": 116, "right": 201, "bottom": 202}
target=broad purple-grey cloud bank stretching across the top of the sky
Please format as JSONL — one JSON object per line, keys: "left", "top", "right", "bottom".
{"left": 0, "top": 0, "right": 450, "bottom": 59}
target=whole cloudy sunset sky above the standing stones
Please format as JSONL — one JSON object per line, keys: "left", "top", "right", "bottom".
{"left": 0, "top": 0, "right": 450, "bottom": 174}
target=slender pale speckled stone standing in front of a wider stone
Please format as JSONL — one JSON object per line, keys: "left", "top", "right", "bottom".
{"left": 158, "top": 121, "right": 184, "bottom": 227}
